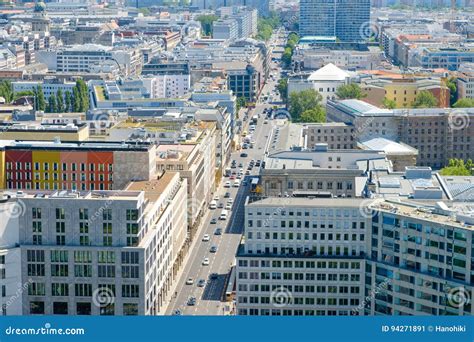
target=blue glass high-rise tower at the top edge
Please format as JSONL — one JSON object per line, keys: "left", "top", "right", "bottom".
{"left": 300, "top": 0, "right": 370, "bottom": 42}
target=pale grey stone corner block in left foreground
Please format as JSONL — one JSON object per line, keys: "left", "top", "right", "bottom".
{"left": 0, "top": 173, "right": 187, "bottom": 315}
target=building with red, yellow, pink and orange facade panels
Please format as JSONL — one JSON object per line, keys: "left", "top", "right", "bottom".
{"left": 0, "top": 141, "right": 156, "bottom": 191}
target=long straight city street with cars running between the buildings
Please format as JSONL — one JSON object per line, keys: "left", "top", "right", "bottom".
{"left": 166, "top": 31, "right": 281, "bottom": 315}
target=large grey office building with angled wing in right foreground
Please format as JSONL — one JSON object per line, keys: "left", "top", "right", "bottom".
{"left": 236, "top": 167, "right": 474, "bottom": 316}
